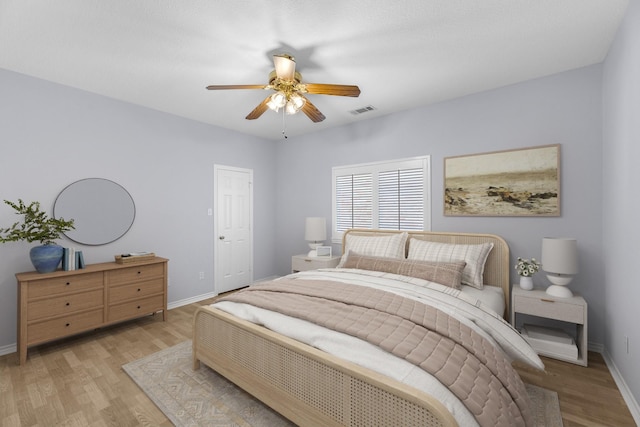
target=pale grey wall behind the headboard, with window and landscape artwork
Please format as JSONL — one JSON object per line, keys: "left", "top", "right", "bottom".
{"left": 277, "top": 66, "right": 605, "bottom": 344}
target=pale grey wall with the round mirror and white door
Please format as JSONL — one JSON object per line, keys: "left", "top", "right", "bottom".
{"left": 0, "top": 70, "right": 276, "bottom": 354}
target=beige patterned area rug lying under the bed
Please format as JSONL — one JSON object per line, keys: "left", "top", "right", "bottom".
{"left": 122, "top": 341, "right": 562, "bottom": 427}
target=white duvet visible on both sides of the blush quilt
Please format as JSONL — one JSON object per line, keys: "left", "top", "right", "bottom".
{"left": 213, "top": 269, "right": 543, "bottom": 426}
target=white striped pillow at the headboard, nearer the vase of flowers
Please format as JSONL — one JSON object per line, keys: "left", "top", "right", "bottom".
{"left": 407, "top": 239, "right": 493, "bottom": 289}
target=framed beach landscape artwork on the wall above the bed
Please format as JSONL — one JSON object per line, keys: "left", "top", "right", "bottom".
{"left": 444, "top": 144, "right": 560, "bottom": 216}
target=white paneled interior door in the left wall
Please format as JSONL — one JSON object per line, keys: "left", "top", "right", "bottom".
{"left": 214, "top": 165, "right": 253, "bottom": 293}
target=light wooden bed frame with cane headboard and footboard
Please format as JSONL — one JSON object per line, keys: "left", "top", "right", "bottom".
{"left": 193, "top": 230, "right": 510, "bottom": 427}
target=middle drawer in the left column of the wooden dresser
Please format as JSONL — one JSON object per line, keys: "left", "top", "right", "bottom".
{"left": 27, "top": 289, "right": 104, "bottom": 321}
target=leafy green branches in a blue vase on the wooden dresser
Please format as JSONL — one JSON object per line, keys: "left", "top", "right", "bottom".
{"left": 0, "top": 199, "right": 75, "bottom": 273}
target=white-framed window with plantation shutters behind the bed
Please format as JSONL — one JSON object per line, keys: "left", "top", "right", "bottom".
{"left": 332, "top": 156, "right": 431, "bottom": 243}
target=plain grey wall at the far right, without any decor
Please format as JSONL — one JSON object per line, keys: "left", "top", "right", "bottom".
{"left": 602, "top": 1, "right": 640, "bottom": 400}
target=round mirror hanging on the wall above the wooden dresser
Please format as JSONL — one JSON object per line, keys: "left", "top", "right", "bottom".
{"left": 53, "top": 178, "right": 136, "bottom": 245}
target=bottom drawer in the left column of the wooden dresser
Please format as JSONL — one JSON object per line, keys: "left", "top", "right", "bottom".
{"left": 27, "top": 309, "right": 104, "bottom": 345}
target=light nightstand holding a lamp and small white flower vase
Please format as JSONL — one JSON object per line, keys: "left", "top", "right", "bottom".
{"left": 511, "top": 285, "right": 587, "bottom": 366}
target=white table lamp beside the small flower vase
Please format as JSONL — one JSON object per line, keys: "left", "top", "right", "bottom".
{"left": 541, "top": 237, "right": 578, "bottom": 298}
